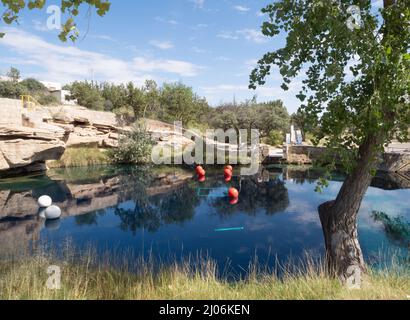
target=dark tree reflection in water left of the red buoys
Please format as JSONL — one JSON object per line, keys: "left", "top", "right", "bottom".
{"left": 115, "top": 167, "right": 199, "bottom": 233}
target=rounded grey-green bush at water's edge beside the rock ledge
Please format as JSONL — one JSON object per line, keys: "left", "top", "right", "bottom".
{"left": 110, "top": 124, "right": 153, "bottom": 164}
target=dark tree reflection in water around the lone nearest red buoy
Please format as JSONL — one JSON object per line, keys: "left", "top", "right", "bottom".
{"left": 213, "top": 176, "right": 289, "bottom": 215}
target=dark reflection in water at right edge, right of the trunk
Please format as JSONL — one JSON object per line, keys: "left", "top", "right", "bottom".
{"left": 371, "top": 211, "right": 410, "bottom": 249}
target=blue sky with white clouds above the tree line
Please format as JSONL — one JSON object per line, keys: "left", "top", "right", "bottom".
{"left": 0, "top": 0, "right": 384, "bottom": 113}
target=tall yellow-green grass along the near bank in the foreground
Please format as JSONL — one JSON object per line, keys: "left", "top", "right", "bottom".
{"left": 0, "top": 250, "right": 410, "bottom": 300}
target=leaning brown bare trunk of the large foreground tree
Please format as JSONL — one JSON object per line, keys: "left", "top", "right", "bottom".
{"left": 319, "top": 137, "right": 379, "bottom": 287}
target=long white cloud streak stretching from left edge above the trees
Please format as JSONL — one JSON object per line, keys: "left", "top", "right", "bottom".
{"left": 0, "top": 28, "right": 202, "bottom": 84}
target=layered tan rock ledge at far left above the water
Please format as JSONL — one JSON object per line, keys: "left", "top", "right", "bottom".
{"left": 0, "top": 99, "right": 123, "bottom": 175}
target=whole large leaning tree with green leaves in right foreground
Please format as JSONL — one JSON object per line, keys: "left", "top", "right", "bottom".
{"left": 250, "top": 0, "right": 410, "bottom": 281}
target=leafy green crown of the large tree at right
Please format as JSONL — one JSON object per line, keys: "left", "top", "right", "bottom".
{"left": 250, "top": 0, "right": 410, "bottom": 175}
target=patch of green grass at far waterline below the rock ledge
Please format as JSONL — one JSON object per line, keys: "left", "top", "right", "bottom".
{"left": 47, "top": 148, "right": 110, "bottom": 169}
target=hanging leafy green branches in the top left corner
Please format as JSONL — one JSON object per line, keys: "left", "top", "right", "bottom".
{"left": 0, "top": 0, "right": 111, "bottom": 41}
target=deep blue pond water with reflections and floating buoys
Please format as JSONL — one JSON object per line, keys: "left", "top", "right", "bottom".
{"left": 0, "top": 167, "right": 410, "bottom": 273}
